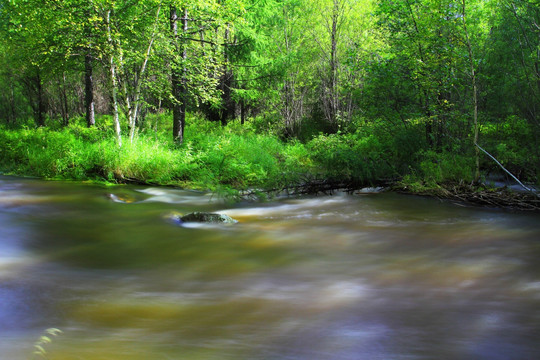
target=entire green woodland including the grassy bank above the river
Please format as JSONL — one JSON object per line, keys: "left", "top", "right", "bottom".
{"left": 0, "top": 0, "right": 540, "bottom": 202}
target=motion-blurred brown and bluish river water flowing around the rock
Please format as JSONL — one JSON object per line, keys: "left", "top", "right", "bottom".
{"left": 0, "top": 177, "right": 540, "bottom": 360}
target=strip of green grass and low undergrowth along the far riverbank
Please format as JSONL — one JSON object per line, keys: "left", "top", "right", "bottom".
{"left": 0, "top": 114, "right": 527, "bottom": 205}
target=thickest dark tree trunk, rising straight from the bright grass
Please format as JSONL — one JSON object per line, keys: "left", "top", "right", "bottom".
{"left": 170, "top": 6, "right": 188, "bottom": 145}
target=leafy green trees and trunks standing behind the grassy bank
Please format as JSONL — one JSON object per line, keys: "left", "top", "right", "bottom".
{"left": 0, "top": 0, "right": 540, "bottom": 190}
